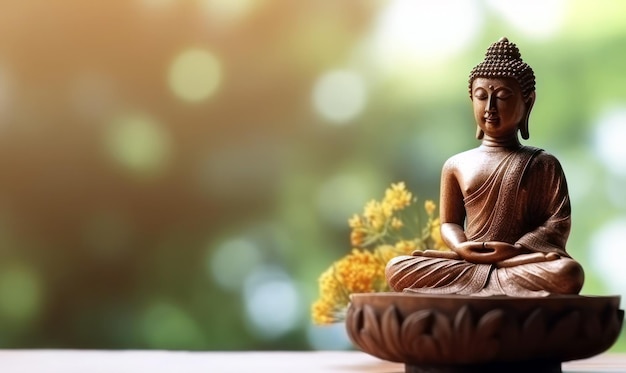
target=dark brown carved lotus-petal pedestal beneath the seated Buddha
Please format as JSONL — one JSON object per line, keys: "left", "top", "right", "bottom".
{"left": 346, "top": 293, "right": 624, "bottom": 372}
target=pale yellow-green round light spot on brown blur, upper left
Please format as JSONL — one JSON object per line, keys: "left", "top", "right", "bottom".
{"left": 169, "top": 49, "right": 222, "bottom": 102}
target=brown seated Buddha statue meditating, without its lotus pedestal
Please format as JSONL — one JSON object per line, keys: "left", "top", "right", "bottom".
{"left": 386, "top": 38, "right": 584, "bottom": 297}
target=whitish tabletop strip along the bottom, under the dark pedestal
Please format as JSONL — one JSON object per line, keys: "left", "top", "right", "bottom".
{"left": 0, "top": 350, "right": 626, "bottom": 373}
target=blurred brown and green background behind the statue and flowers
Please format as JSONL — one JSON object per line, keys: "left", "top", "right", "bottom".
{"left": 0, "top": 0, "right": 626, "bottom": 351}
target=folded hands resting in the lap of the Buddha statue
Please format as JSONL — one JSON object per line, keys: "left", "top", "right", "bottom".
{"left": 454, "top": 241, "right": 524, "bottom": 264}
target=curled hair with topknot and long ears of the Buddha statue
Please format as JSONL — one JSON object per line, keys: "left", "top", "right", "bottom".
{"left": 469, "top": 38, "right": 535, "bottom": 139}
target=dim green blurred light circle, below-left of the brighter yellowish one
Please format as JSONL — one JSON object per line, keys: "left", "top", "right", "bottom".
{"left": 105, "top": 113, "right": 172, "bottom": 176}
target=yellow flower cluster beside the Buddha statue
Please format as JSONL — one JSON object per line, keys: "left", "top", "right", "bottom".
{"left": 312, "top": 182, "right": 448, "bottom": 324}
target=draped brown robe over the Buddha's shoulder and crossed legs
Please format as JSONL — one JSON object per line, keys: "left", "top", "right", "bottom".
{"left": 386, "top": 147, "right": 583, "bottom": 296}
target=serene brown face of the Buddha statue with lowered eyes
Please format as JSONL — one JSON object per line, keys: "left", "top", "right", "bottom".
{"left": 472, "top": 78, "right": 526, "bottom": 140}
